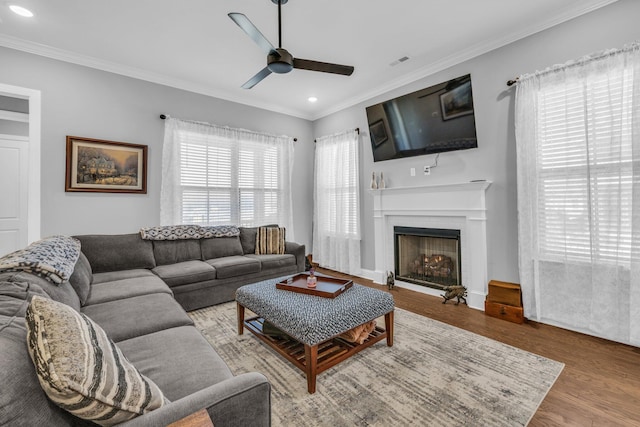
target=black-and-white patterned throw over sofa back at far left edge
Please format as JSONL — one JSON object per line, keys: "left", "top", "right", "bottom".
{"left": 0, "top": 236, "right": 80, "bottom": 284}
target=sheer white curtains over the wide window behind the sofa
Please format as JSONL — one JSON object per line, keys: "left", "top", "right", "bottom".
{"left": 160, "top": 118, "right": 294, "bottom": 240}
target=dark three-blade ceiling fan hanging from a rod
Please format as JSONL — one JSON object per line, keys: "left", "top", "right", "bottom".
{"left": 229, "top": 0, "right": 354, "bottom": 89}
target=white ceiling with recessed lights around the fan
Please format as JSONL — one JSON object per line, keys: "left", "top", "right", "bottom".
{"left": 0, "top": 0, "right": 617, "bottom": 120}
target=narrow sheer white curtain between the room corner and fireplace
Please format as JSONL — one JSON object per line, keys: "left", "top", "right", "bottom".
{"left": 313, "top": 130, "right": 360, "bottom": 274}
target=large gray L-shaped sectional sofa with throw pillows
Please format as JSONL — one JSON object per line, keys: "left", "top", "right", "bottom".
{"left": 0, "top": 228, "right": 305, "bottom": 427}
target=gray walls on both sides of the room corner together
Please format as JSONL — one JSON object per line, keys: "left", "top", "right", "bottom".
{"left": 0, "top": 0, "right": 640, "bottom": 282}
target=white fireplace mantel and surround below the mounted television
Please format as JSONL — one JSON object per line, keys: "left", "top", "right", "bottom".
{"left": 371, "top": 181, "right": 491, "bottom": 310}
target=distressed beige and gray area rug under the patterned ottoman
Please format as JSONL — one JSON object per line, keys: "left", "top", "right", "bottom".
{"left": 189, "top": 302, "right": 564, "bottom": 427}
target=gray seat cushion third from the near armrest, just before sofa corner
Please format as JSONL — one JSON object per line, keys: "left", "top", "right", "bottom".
{"left": 85, "top": 276, "right": 173, "bottom": 305}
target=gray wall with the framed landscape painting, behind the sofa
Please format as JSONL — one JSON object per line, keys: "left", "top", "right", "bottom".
{"left": 0, "top": 48, "right": 313, "bottom": 250}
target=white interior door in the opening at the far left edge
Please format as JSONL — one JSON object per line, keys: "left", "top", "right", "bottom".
{"left": 0, "top": 135, "right": 29, "bottom": 256}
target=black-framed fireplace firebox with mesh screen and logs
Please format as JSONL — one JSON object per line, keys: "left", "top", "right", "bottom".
{"left": 393, "top": 226, "right": 462, "bottom": 290}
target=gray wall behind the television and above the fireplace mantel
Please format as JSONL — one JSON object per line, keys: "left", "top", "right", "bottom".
{"left": 314, "top": 0, "right": 640, "bottom": 282}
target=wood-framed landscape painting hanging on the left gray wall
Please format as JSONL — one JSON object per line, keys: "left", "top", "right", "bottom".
{"left": 65, "top": 136, "right": 148, "bottom": 194}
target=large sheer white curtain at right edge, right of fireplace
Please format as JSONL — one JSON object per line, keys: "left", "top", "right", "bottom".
{"left": 515, "top": 44, "right": 640, "bottom": 345}
